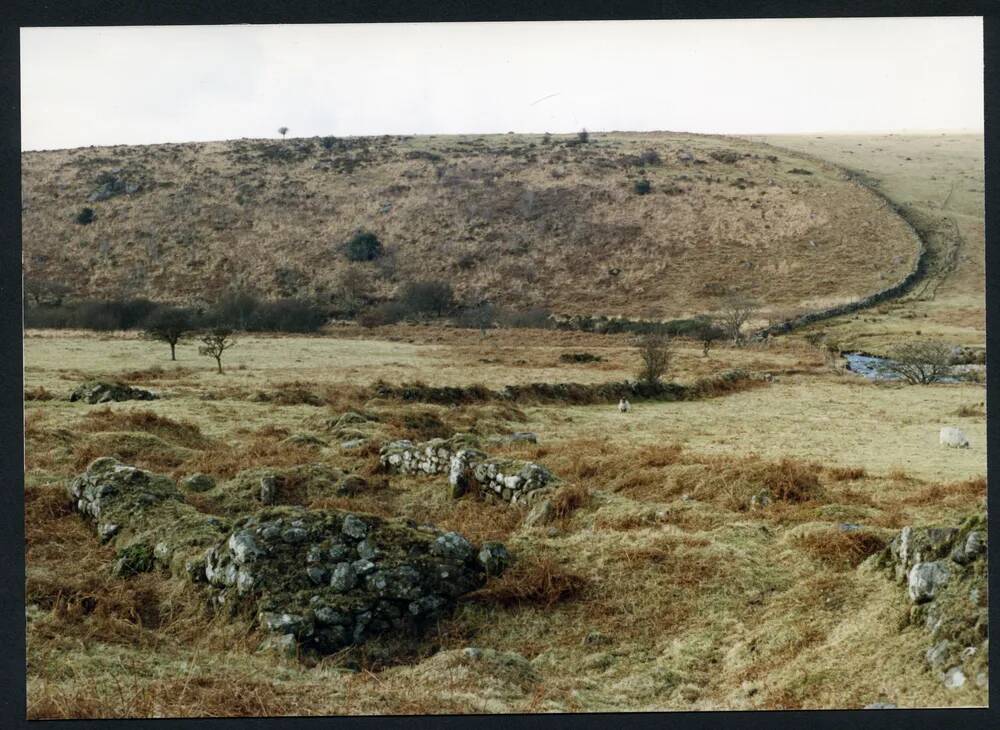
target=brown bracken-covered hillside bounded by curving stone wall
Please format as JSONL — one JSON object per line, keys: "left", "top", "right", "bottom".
{"left": 22, "top": 133, "right": 919, "bottom": 318}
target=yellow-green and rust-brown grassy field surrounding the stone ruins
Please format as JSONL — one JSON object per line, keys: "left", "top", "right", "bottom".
{"left": 25, "top": 327, "right": 986, "bottom": 717}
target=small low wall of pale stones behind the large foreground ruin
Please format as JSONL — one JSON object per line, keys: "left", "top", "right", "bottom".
{"left": 379, "top": 434, "right": 557, "bottom": 505}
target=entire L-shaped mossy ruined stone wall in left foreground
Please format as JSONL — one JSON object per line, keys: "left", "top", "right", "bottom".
{"left": 68, "top": 457, "right": 509, "bottom": 653}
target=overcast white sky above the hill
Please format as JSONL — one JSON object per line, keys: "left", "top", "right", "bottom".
{"left": 21, "top": 18, "right": 983, "bottom": 149}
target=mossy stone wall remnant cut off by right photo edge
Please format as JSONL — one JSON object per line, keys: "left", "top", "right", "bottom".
{"left": 870, "top": 513, "right": 989, "bottom": 689}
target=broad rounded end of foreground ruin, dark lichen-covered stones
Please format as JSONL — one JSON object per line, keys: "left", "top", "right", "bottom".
{"left": 205, "top": 508, "right": 507, "bottom": 652}
